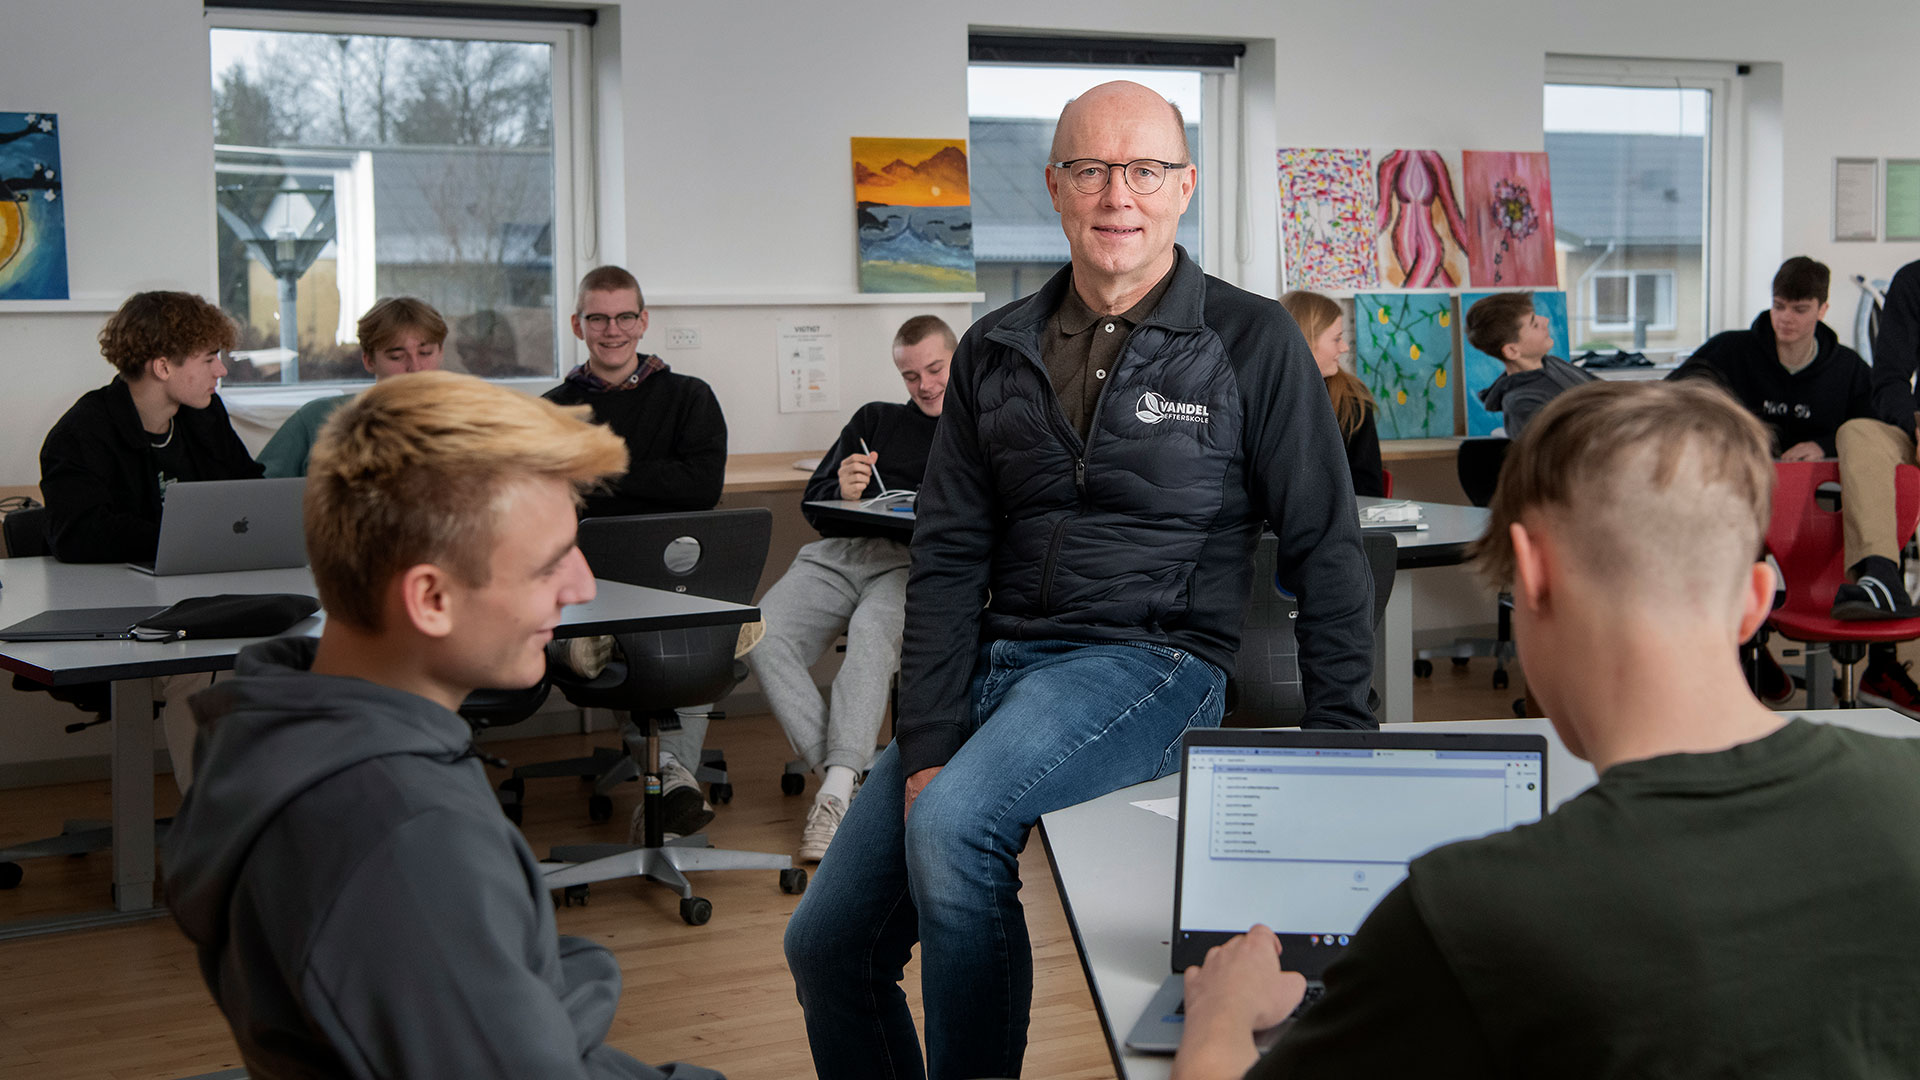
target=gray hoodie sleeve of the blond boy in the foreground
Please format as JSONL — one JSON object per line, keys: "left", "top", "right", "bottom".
{"left": 301, "top": 811, "right": 720, "bottom": 1080}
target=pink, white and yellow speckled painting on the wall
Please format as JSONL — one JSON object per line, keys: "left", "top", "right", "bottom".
{"left": 1279, "top": 150, "right": 1380, "bottom": 288}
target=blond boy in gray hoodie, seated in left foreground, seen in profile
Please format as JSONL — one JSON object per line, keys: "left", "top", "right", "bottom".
{"left": 165, "top": 373, "right": 718, "bottom": 1080}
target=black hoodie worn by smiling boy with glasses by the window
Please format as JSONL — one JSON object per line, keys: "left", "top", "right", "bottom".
{"left": 545, "top": 361, "right": 726, "bottom": 517}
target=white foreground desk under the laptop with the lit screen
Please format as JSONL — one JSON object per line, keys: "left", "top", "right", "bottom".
{"left": 1041, "top": 709, "right": 1920, "bottom": 1080}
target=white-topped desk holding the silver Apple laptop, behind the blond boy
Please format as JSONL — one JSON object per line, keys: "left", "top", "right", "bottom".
{"left": 0, "top": 557, "right": 760, "bottom": 938}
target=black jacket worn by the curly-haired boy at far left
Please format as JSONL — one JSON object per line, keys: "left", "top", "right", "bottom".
{"left": 40, "top": 377, "right": 261, "bottom": 563}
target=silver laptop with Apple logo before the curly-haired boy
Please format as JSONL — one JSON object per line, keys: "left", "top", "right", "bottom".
{"left": 127, "top": 477, "right": 307, "bottom": 577}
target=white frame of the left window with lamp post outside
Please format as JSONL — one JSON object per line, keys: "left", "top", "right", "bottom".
{"left": 202, "top": 8, "right": 599, "bottom": 393}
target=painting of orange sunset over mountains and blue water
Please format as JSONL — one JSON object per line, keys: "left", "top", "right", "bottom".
{"left": 852, "top": 138, "right": 975, "bottom": 292}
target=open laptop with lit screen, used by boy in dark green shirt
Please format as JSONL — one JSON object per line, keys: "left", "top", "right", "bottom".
{"left": 1127, "top": 728, "right": 1548, "bottom": 1053}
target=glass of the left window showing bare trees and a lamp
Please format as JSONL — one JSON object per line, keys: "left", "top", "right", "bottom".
{"left": 211, "top": 29, "right": 557, "bottom": 382}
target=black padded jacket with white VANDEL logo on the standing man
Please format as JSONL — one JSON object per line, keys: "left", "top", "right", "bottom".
{"left": 899, "top": 250, "right": 1375, "bottom": 774}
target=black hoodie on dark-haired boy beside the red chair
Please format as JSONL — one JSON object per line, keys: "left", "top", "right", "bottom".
{"left": 1668, "top": 311, "right": 1874, "bottom": 457}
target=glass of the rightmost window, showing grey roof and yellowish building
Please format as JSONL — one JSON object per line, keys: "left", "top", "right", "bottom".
{"left": 1546, "top": 83, "right": 1713, "bottom": 359}
